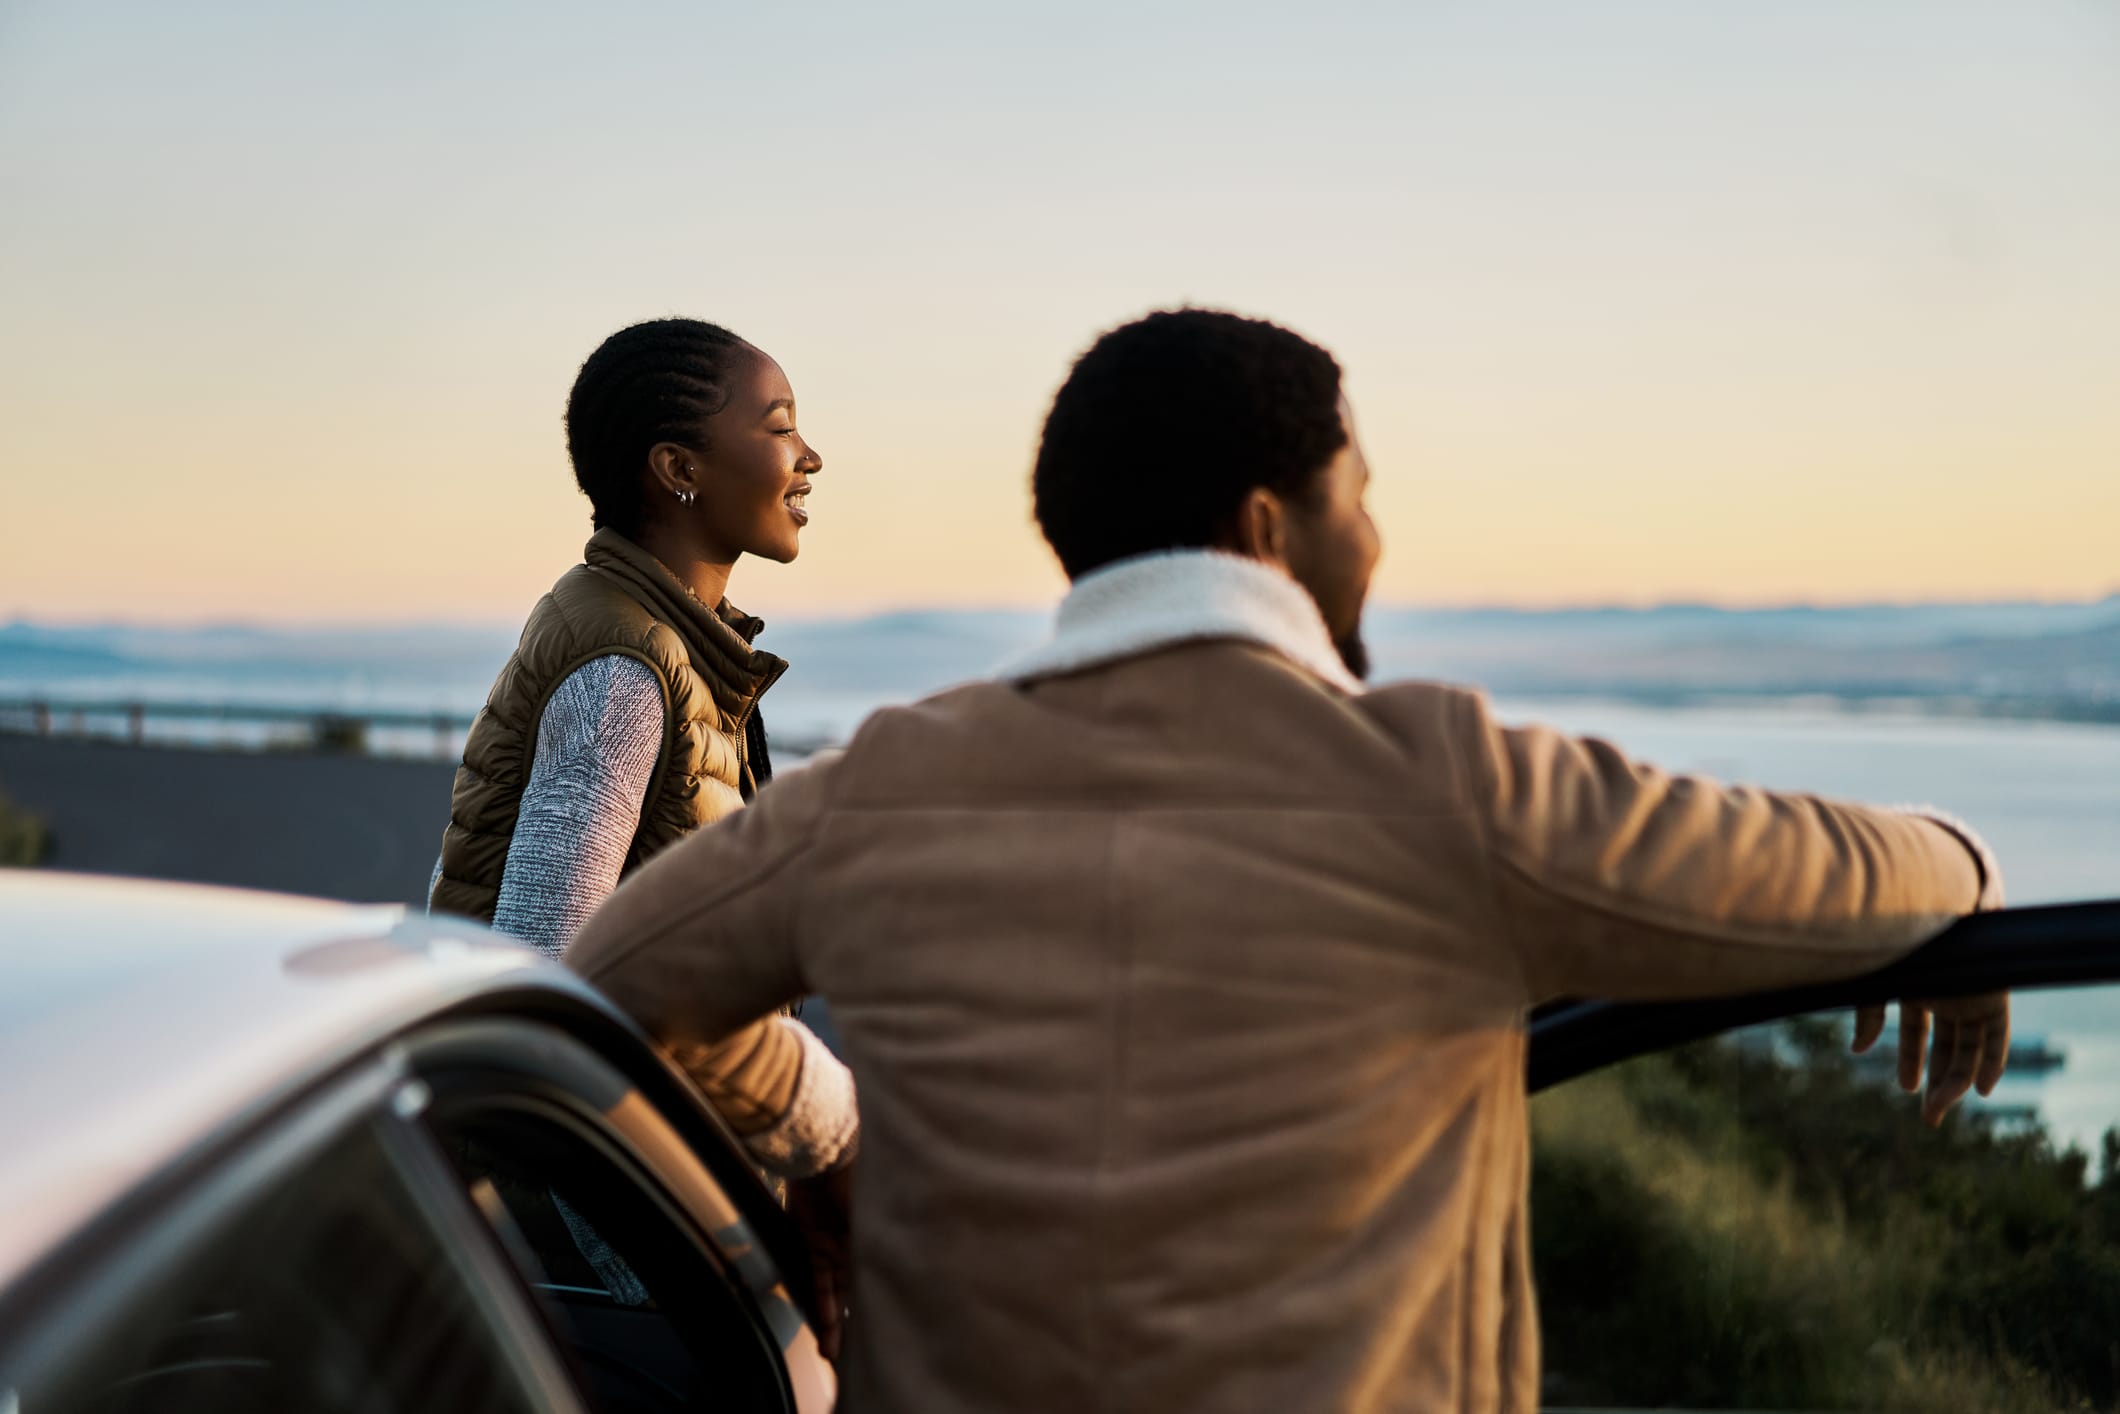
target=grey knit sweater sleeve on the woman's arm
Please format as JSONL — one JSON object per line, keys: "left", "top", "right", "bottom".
{"left": 494, "top": 653, "right": 664, "bottom": 958}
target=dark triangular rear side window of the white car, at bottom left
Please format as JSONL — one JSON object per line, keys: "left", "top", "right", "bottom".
{"left": 19, "top": 1132, "right": 543, "bottom": 1414}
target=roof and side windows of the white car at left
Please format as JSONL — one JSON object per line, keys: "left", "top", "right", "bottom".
{"left": 0, "top": 871, "right": 833, "bottom": 1414}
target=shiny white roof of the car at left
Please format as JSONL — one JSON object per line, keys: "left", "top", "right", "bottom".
{"left": 0, "top": 869, "right": 594, "bottom": 1287}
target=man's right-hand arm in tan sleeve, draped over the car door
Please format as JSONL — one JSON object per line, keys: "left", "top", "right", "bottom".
{"left": 1465, "top": 697, "right": 2010, "bottom": 1124}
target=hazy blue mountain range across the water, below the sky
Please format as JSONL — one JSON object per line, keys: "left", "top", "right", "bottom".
{"left": 0, "top": 596, "right": 2120, "bottom": 731}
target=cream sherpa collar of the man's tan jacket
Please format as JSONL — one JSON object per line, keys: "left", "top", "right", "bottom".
{"left": 999, "top": 549, "right": 1361, "bottom": 693}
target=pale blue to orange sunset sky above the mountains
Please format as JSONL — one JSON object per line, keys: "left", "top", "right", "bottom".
{"left": 0, "top": 0, "right": 2120, "bottom": 621}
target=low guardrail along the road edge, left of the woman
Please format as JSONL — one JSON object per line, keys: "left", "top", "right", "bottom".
{"left": 0, "top": 697, "right": 471, "bottom": 757}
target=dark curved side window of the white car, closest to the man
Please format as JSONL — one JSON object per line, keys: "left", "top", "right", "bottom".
{"left": 435, "top": 1109, "right": 791, "bottom": 1414}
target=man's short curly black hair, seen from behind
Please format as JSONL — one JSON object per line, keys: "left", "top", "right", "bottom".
{"left": 1030, "top": 310, "right": 1346, "bottom": 579}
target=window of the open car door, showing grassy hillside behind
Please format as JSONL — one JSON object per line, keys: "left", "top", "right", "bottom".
{"left": 1533, "top": 988, "right": 2120, "bottom": 1414}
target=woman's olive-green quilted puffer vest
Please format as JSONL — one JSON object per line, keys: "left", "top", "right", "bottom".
{"left": 430, "top": 530, "right": 787, "bottom": 922}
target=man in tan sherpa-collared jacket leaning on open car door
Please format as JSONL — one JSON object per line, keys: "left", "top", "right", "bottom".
{"left": 570, "top": 310, "right": 2008, "bottom": 1414}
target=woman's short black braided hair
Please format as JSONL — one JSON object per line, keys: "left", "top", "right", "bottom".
{"left": 566, "top": 320, "right": 750, "bottom": 536}
